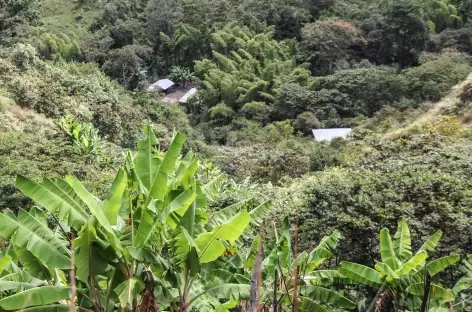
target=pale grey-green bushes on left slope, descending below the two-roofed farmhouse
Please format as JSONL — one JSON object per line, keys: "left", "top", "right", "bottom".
{"left": 0, "top": 45, "right": 197, "bottom": 147}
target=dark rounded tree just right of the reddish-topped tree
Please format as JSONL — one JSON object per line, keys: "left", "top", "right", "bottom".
{"left": 363, "top": 0, "right": 428, "bottom": 68}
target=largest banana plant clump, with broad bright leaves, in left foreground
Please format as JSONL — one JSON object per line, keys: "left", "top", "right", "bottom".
{"left": 0, "top": 125, "right": 270, "bottom": 312}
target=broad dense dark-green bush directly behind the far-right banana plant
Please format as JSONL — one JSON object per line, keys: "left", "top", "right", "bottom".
{"left": 293, "top": 136, "right": 472, "bottom": 265}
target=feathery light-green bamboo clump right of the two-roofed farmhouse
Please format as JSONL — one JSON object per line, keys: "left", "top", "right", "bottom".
{"left": 195, "top": 23, "right": 312, "bottom": 109}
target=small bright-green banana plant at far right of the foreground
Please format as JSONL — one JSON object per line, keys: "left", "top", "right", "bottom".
{"left": 338, "top": 219, "right": 460, "bottom": 312}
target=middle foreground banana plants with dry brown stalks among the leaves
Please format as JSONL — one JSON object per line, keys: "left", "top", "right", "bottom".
{"left": 210, "top": 218, "right": 356, "bottom": 312}
